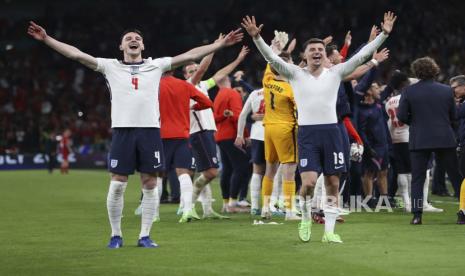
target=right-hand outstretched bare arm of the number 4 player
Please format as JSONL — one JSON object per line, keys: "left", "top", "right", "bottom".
{"left": 171, "top": 29, "right": 243, "bottom": 69}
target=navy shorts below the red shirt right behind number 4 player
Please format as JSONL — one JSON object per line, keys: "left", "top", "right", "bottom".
{"left": 162, "top": 139, "right": 195, "bottom": 171}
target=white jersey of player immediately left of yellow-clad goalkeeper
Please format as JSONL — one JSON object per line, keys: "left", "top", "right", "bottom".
{"left": 237, "top": 88, "right": 265, "bottom": 141}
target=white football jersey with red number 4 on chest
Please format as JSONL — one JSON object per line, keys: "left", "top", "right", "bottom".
{"left": 95, "top": 57, "right": 171, "bottom": 128}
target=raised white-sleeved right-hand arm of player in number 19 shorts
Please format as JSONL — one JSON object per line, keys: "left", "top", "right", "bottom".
{"left": 334, "top": 12, "right": 397, "bottom": 79}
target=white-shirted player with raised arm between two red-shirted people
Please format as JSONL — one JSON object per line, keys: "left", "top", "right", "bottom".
{"left": 183, "top": 44, "right": 249, "bottom": 219}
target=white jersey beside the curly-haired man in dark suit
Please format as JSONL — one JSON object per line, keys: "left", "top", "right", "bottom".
{"left": 386, "top": 95, "right": 409, "bottom": 144}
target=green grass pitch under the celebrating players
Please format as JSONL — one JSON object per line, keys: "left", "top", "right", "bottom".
{"left": 0, "top": 170, "right": 465, "bottom": 275}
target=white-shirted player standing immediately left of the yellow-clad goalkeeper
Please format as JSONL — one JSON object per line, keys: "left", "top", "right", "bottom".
{"left": 234, "top": 89, "right": 265, "bottom": 215}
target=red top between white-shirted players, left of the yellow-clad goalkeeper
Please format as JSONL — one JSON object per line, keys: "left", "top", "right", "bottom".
{"left": 213, "top": 88, "right": 242, "bottom": 142}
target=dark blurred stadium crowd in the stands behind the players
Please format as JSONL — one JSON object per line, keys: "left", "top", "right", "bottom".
{"left": 0, "top": 0, "right": 465, "bottom": 152}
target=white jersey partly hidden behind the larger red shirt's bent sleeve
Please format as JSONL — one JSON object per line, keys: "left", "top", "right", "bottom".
{"left": 187, "top": 79, "right": 216, "bottom": 134}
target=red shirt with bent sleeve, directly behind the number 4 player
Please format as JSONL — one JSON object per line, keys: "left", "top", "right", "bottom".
{"left": 159, "top": 75, "right": 213, "bottom": 139}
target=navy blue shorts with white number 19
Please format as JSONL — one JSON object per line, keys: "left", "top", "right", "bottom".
{"left": 297, "top": 124, "right": 346, "bottom": 175}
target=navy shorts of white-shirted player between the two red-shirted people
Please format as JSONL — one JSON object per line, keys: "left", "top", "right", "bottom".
{"left": 190, "top": 130, "right": 219, "bottom": 172}
